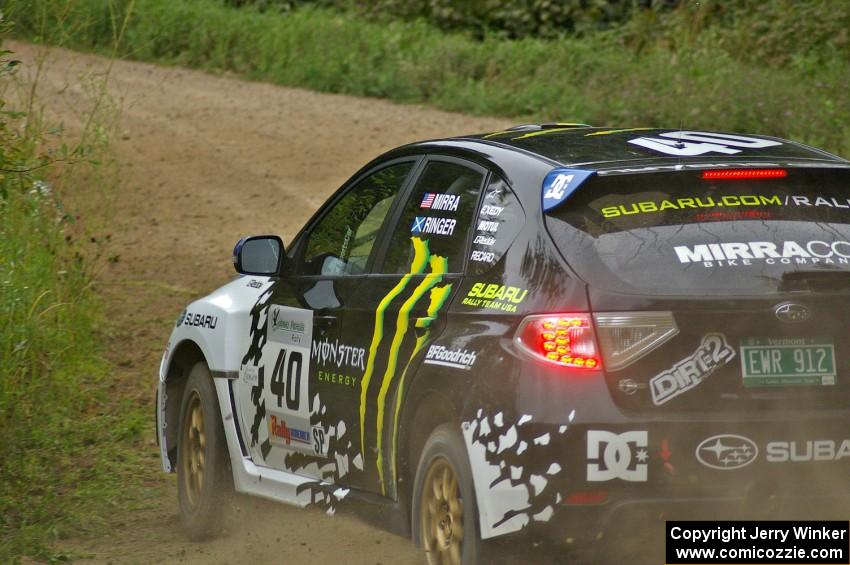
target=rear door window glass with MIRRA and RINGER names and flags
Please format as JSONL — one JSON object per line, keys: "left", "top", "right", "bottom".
{"left": 381, "top": 160, "right": 484, "bottom": 273}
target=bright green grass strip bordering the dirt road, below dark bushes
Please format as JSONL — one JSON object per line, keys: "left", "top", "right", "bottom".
{"left": 6, "top": 0, "right": 850, "bottom": 154}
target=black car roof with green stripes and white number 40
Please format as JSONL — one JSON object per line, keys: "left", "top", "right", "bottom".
{"left": 454, "top": 123, "right": 850, "bottom": 170}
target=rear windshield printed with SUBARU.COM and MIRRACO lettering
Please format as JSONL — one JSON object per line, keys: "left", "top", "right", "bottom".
{"left": 546, "top": 168, "right": 850, "bottom": 295}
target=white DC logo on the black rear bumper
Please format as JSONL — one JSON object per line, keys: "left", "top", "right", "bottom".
{"left": 587, "top": 430, "right": 649, "bottom": 482}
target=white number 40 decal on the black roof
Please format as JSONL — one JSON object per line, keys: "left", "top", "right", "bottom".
{"left": 629, "top": 131, "right": 782, "bottom": 157}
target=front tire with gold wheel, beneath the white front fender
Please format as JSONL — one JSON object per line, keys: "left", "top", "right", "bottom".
{"left": 177, "top": 363, "right": 233, "bottom": 540}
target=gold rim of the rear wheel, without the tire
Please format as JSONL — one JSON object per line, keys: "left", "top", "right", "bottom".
{"left": 419, "top": 457, "right": 463, "bottom": 565}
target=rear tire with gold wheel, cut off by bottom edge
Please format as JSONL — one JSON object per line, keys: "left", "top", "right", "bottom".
{"left": 411, "top": 424, "right": 481, "bottom": 565}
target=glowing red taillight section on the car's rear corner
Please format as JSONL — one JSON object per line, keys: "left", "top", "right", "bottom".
{"left": 516, "top": 314, "right": 600, "bottom": 369}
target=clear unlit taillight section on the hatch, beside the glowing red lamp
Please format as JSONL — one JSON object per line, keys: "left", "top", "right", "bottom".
{"left": 593, "top": 312, "right": 679, "bottom": 371}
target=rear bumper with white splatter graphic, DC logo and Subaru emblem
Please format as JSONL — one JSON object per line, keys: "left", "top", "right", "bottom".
{"left": 464, "top": 413, "right": 850, "bottom": 543}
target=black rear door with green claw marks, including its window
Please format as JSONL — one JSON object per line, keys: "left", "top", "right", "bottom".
{"left": 342, "top": 156, "right": 487, "bottom": 495}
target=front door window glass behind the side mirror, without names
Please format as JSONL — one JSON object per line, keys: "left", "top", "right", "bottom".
{"left": 297, "top": 161, "right": 414, "bottom": 276}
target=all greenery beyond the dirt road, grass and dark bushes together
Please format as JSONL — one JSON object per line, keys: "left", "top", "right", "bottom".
{"left": 6, "top": 0, "right": 850, "bottom": 155}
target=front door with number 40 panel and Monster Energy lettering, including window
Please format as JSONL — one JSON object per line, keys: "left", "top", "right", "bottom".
{"left": 234, "top": 160, "right": 416, "bottom": 483}
